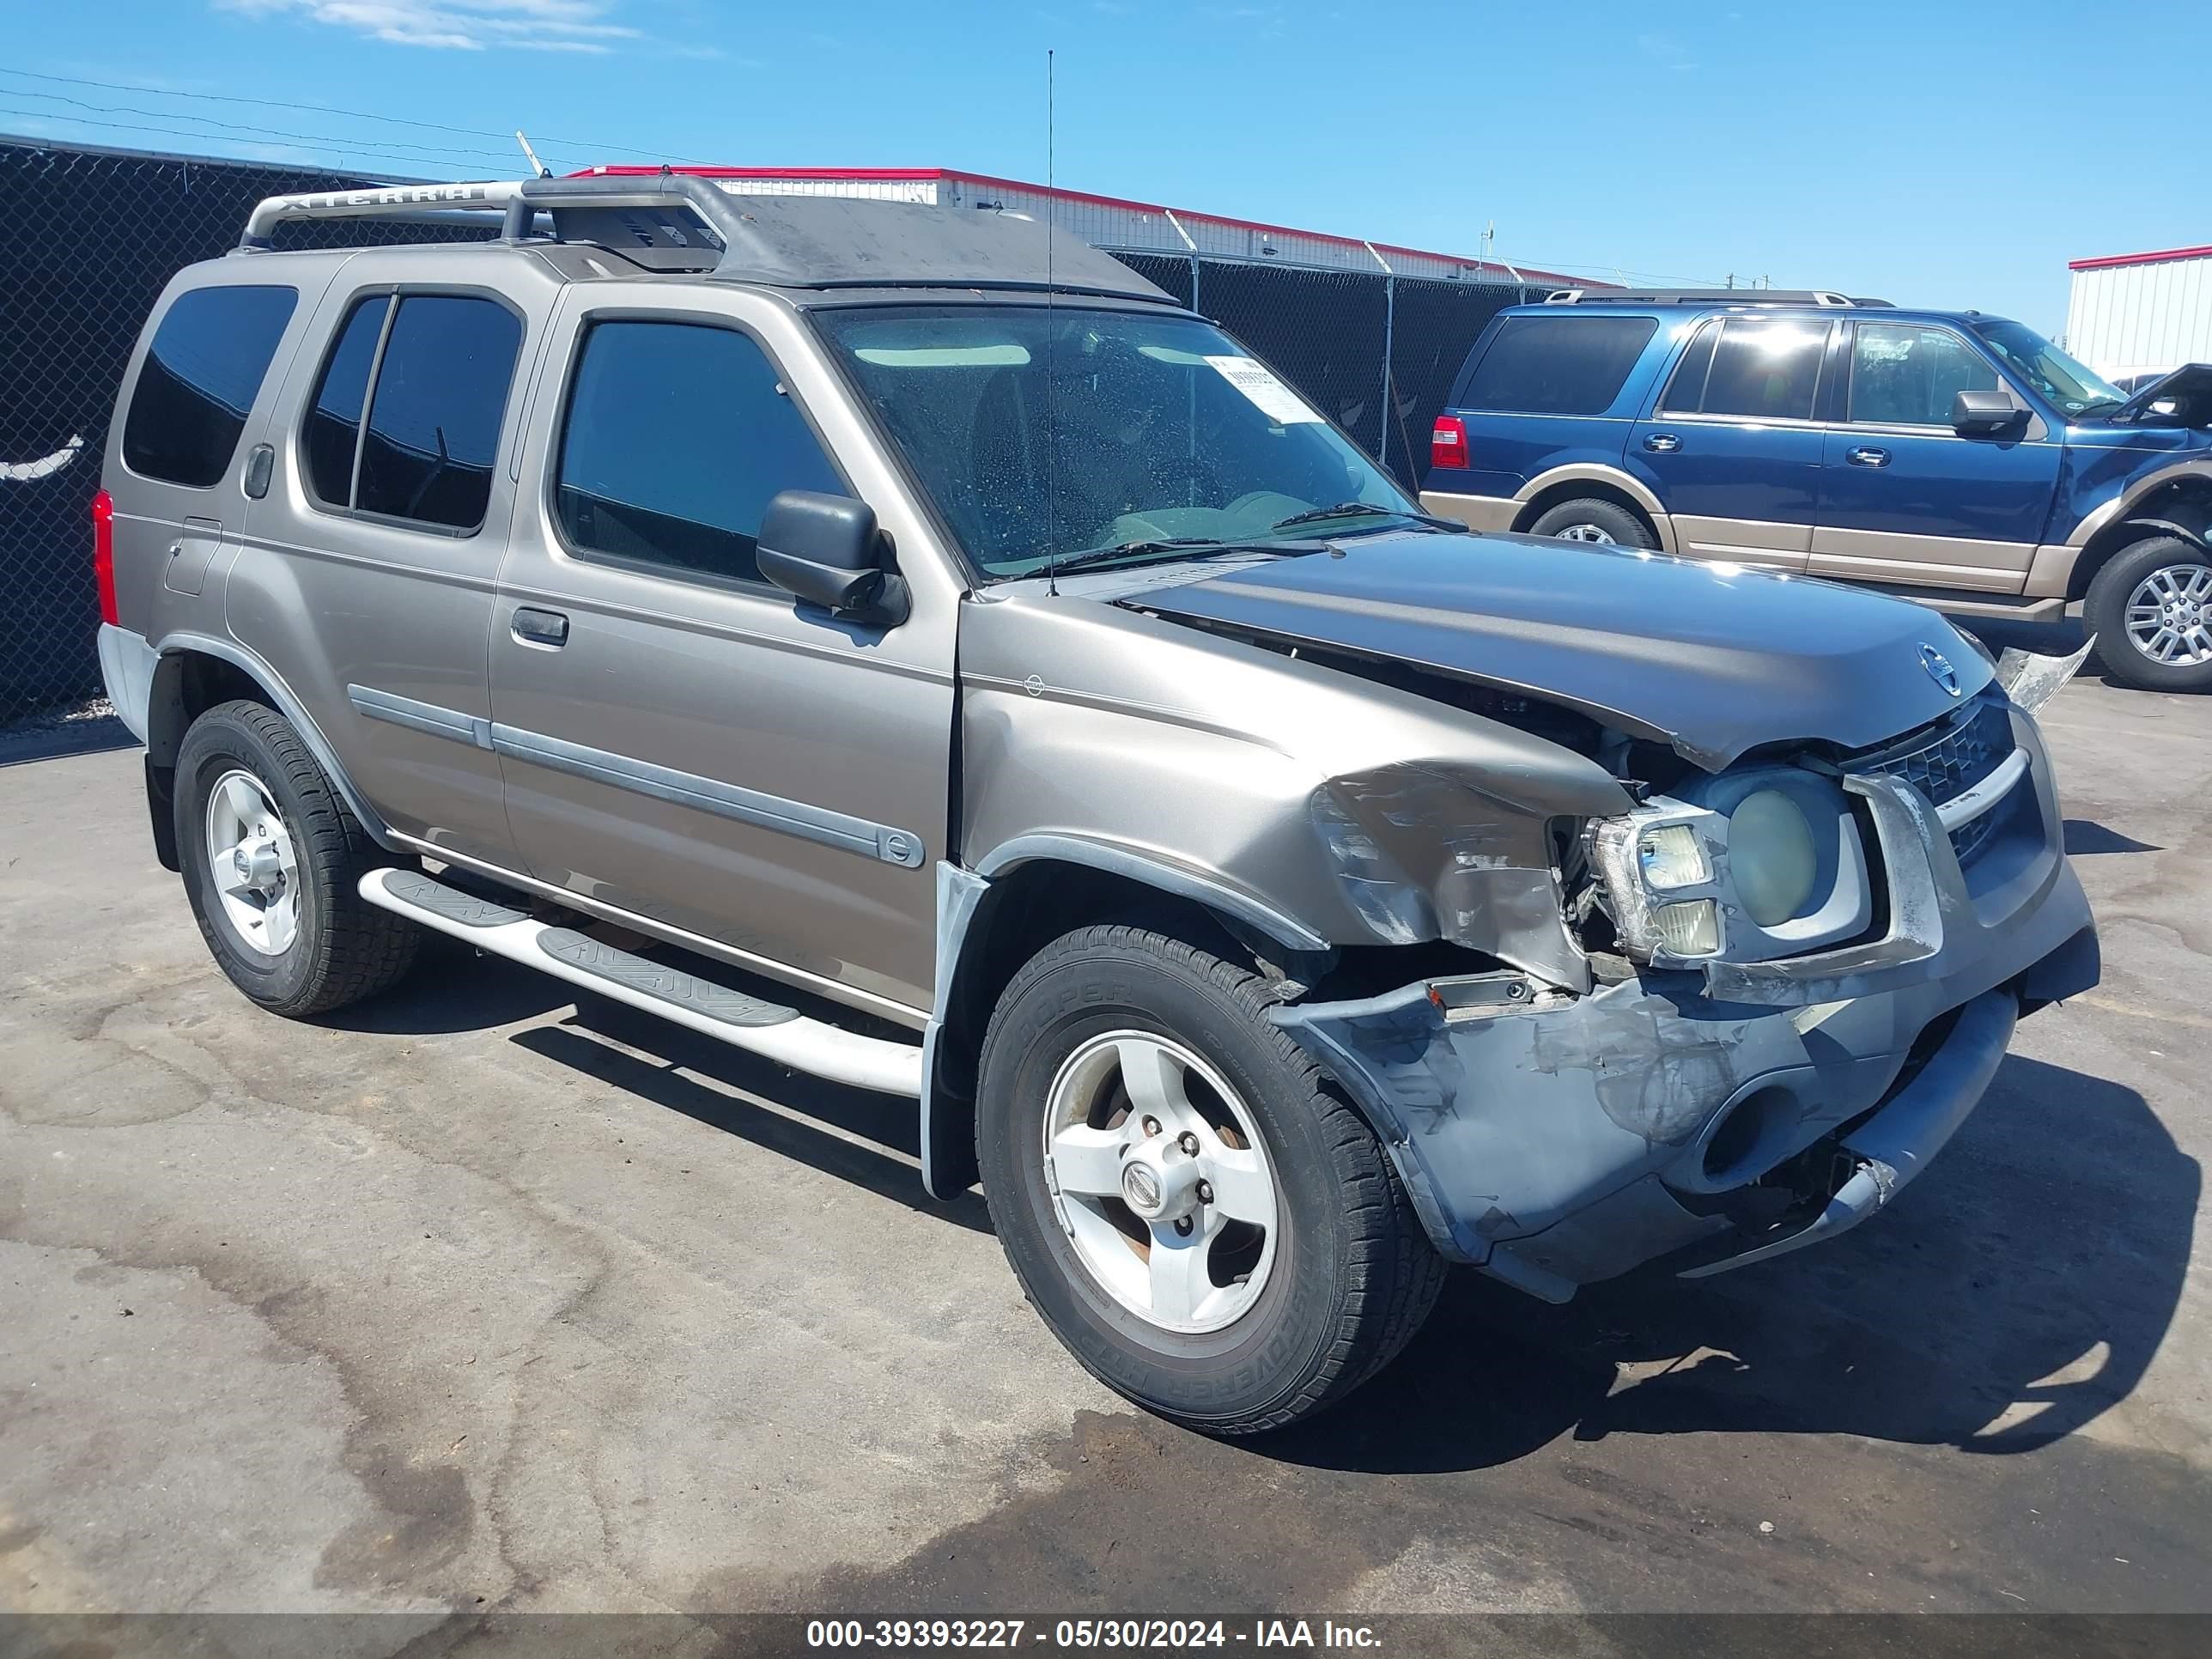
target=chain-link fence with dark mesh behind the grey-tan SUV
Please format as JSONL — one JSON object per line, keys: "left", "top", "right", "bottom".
{"left": 0, "top": 139, "right": 1537, "bottom": 726}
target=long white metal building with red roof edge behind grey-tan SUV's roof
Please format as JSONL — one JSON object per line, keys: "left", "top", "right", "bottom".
{"left": 570, "top": 166, "right": 1608, "bottom": 288}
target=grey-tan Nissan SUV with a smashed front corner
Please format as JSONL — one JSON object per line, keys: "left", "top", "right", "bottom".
{"left": 95, "top": 175, "right": 2097, "bottom": 1433}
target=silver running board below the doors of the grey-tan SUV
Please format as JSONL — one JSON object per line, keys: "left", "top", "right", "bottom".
{"left": 361, "top": 869, "right": 922, "bottom": 1099}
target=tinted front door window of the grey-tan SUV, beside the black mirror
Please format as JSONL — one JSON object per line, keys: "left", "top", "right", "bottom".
{"left": 556, "top": 323, "right": 848, "bottom": 581}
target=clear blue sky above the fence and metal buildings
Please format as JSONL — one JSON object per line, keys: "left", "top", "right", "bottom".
{"left": 0, "top": 0, "right": 2212, "bottom": 334}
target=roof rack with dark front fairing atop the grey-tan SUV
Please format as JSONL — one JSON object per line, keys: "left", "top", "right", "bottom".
{"left": 239, "top": 173, "right": 1175, "bottom": 305}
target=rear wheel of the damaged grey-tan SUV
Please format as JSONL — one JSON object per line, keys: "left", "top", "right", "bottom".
{"left": 175, "top": 702, "right": 420, "bottom": 1018}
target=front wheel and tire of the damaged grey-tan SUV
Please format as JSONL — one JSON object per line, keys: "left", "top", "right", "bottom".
{"left": 975, "top": 927, "right": 1444, "bottom": 1436}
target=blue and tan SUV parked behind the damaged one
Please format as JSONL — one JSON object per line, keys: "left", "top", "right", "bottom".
{"left": 1422, "top": 289, "right": 2212, "bottom": 690}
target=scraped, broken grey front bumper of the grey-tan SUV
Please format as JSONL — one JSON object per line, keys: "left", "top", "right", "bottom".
{"left": 1272, "top": 719, "right": 2097, "bottom": 1301}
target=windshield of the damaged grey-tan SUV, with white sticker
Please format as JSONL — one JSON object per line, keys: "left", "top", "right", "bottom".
{"left": 814, "top": 305, "right": 1418, "bottom": 577}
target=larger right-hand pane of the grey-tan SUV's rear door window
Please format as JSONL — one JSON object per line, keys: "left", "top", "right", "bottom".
{"left": 354, "top": 295, "right": 522, "bottom": 531}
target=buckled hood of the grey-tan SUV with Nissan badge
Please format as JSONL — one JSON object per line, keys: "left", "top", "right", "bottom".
{"left": 1119, "top": 533, "right": 1990, "bottom": 772}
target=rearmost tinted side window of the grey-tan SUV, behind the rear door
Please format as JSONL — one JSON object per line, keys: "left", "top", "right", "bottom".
{"left": 124, "top": 288, "right": 299, "bottom": 487}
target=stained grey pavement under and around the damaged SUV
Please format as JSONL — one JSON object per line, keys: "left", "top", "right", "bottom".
{"left": 0, "top": 679, "right": 2212, "bottom": 1652}
